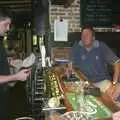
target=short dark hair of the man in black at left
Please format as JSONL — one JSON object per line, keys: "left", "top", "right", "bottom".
{"left": 0, "top": 6, "right": 13, "bottom": 21}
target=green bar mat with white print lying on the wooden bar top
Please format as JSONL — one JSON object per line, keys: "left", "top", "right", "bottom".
{"left": 66, "top": 93, "right": 112, "bottom": 119}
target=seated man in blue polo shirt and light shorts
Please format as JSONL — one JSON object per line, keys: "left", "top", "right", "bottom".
{"left": 71, "top": 25, "right": 120, "bottom": 97}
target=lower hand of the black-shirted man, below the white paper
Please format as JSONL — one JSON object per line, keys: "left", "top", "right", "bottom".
{"left": 14, "top": 69, "right": 31, "bottom": 81}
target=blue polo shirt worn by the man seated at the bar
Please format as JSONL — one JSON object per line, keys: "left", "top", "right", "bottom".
{"left": 70, "top": 40, "right": 119, "bottom": 82}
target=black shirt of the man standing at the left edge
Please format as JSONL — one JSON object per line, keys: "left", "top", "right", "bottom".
{"left": 0, "top": 41, "right": 10, "bottom": 120}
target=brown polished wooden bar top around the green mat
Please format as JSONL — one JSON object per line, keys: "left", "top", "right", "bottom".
{"left": 51, "top": 68, "right": 120, "bottom": 120}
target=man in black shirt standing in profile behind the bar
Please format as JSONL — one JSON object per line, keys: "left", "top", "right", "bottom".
{"left": 0, "top": 8, "right": 30, "bottom": 120}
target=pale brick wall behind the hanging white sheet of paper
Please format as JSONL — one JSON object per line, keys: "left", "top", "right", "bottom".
{"left": 50, "top": 0, "right": 111, "bottom": 32}
